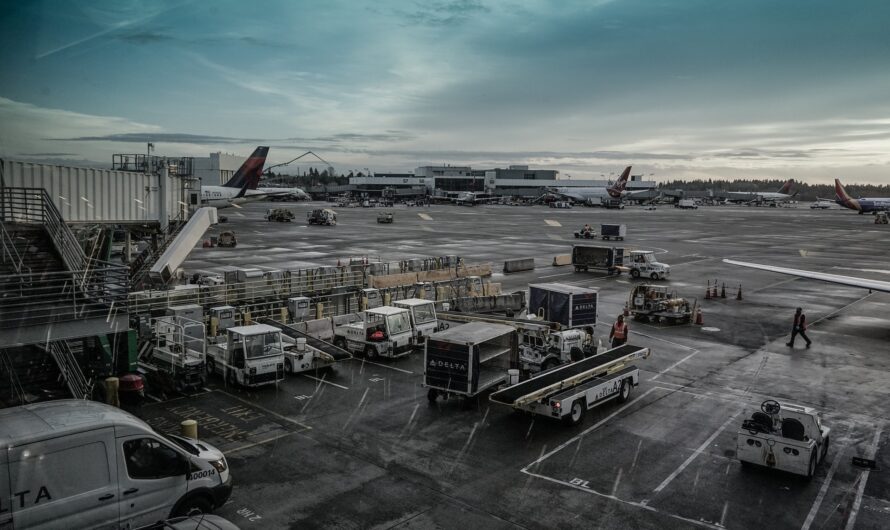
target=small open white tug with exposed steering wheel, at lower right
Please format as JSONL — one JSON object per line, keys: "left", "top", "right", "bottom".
{"left": 736, "top": 399, "right": 831, "bottom": 478}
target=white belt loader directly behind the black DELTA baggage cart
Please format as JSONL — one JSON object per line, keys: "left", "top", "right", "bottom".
{"left": 441, "top": 311, "right": 597, "bottom": 372}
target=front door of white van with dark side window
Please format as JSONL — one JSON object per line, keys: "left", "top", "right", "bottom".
{"left": 117, "top": 435, "right": 190, "bottom": 528}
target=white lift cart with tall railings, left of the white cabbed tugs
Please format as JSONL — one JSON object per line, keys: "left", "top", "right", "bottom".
{"left": 138, "top": 316, "right": 207, "bottom": 393}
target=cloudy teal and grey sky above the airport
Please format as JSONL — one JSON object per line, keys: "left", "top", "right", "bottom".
{"left": 0, "top": 0, "right": 890, "bottom": 184}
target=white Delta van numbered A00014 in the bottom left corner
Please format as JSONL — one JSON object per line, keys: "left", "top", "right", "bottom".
{"left": 0, "top": 399, "right": 232, "bottom": 529}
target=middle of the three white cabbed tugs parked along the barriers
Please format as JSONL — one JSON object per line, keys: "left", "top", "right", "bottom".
{"left": 334, "top": 306, "right": 414, "bottom": 360}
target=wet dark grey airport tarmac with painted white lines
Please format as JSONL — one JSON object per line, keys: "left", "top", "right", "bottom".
{"left": 160, "top": 203, "right": 890, "bottom": 529}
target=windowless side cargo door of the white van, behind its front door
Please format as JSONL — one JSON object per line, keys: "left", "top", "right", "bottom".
{"left": 6, "top": 428, "right": 118, "bottom": 529}
